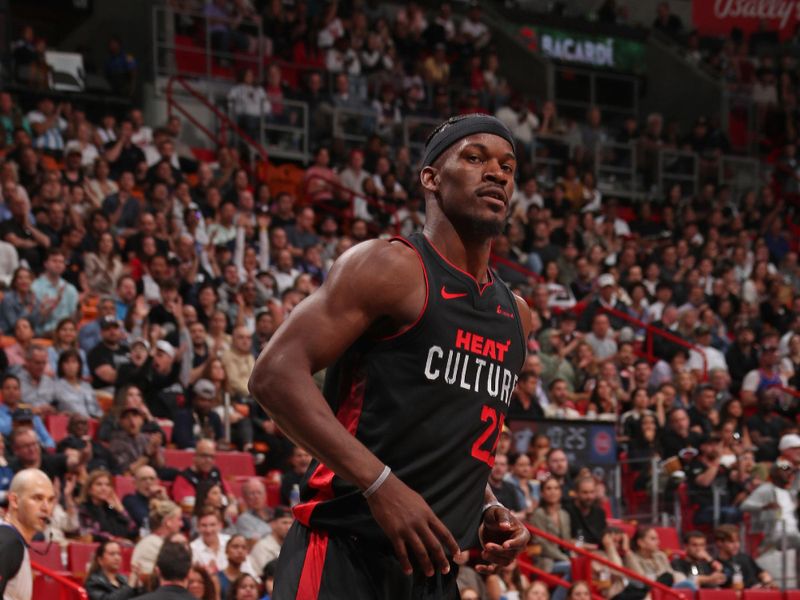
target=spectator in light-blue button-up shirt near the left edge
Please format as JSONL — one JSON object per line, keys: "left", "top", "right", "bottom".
{"left": 31, "top": 248, "right": 78, "bottom": 335}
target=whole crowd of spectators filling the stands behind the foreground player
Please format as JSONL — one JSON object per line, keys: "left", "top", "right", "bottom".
{"left": 0, "top": 0, "right": 800, "bottom": 600}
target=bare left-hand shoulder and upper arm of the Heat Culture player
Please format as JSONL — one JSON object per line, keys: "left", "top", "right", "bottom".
{"left": 257, "top": 242, "right": 426, "bottom": 373}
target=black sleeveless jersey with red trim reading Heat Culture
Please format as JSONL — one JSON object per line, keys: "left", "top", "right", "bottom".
{"left": 294, "top": 234, "right": 526, "bottom": 548}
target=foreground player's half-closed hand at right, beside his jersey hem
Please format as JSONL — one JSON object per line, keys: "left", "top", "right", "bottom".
{"left": 475, "top": 506, "right": 531, "bottom": 574}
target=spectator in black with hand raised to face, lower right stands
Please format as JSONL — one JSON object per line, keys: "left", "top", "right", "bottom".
{"left": 686, "top": 434, "right": 742, "bottom": 524}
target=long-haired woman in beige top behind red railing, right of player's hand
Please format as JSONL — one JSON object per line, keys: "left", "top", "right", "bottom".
{"left": 531, "top": 477, "right": 572, "bottom": 600}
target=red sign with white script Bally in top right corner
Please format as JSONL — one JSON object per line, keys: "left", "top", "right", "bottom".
{"left": 692, "top": 0, "right": 800, "bottom": 39}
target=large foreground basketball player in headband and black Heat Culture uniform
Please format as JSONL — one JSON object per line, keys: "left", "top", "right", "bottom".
{"left": 250, "top": 115, "right": 530, "bottom": 600}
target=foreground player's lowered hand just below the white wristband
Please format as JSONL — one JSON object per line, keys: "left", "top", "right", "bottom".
{"left": 367, "top": 475, "right": 459, "bottom": 577}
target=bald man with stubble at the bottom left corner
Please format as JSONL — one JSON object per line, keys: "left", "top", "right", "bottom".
{"left": 0, "top": 469, "right": 56, "bottom": 600}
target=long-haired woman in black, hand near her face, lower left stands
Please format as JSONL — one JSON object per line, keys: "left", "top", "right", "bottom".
{"left": 78, "top": 470, "right": 138, "bottom": 544}
